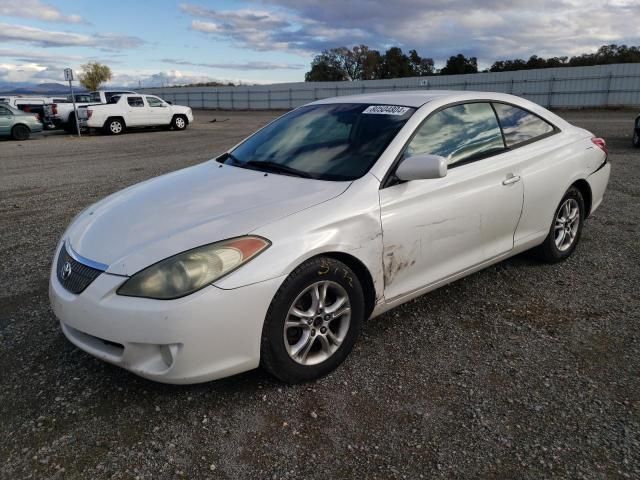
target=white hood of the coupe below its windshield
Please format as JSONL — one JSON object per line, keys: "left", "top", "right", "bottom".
{"left": 65, "top": 161, "right": 350, "bottom": 275}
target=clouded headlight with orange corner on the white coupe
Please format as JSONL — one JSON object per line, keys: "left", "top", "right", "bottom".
{"left": 117, "top": 236, "right": 271, "bottom": 300}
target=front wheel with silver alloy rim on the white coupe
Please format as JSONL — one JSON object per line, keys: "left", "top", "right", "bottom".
{"left": 260, "top": 257, "right": 365, "bottom": 383}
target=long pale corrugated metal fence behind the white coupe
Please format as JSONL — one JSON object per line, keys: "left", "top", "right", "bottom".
{"left": 140, "top": 63, "right": 640, "bottom": 110}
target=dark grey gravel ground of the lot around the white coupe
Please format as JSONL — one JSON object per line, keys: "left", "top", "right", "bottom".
{"left": 0, "top": 111, "right": 640, "bottom": 479}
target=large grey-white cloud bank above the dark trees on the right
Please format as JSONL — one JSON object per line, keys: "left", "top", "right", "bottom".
{"left": 180, "top": 0, "right": 640, "bottom": 64}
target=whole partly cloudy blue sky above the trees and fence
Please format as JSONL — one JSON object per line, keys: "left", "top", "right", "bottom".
{"left": 0, "top": 0, "right": 640, "bottom": 86}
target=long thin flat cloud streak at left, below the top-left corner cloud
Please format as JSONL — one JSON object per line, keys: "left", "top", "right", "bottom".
{"left": 0, "top": 23, "right": 145, "bottom": 50}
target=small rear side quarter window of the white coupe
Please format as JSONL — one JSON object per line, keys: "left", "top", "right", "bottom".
{"left": 493, "top": 103, "right": 553, "bottom": 147}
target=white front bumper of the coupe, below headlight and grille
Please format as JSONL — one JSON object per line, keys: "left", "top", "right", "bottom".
{"left": 49, "top": 248, "right": 284, "bottom": 384}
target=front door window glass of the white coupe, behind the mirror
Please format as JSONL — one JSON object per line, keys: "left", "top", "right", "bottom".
{"left": 404, "top": 103, "right": 505, "bottom": 167}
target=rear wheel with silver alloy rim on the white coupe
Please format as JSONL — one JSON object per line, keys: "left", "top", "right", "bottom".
{"left": 535, "top": 187, "right": 586, "bottom": 263}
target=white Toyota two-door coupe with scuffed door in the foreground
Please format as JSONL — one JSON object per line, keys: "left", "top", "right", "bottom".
{"left": 50, "top": 91, "right": 610, "bottom": 383}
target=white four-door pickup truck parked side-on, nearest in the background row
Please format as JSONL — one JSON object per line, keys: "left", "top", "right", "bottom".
{"left": 78, "top": 94, "right": 193, "bottom": 135}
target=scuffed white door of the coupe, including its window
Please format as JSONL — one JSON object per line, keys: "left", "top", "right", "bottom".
{"left": 380, "top": 103, "right": 523, "bottom": 300}
